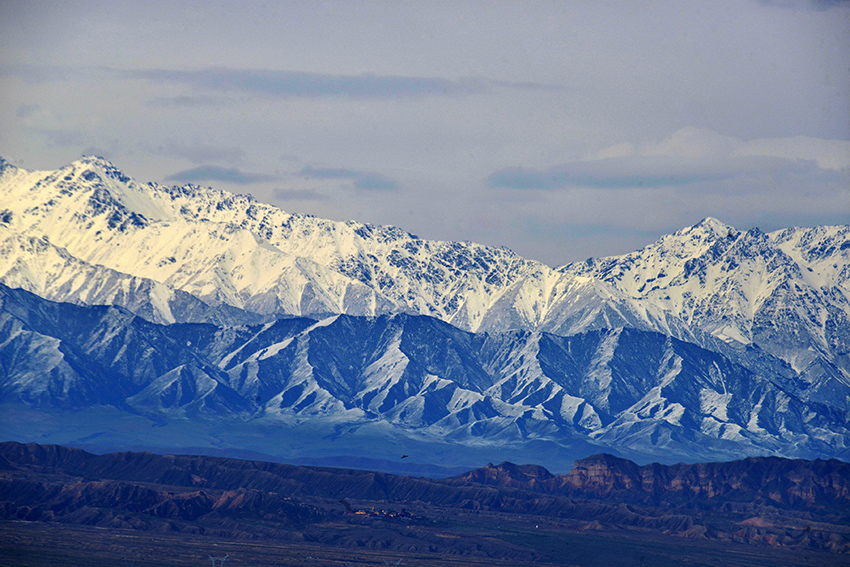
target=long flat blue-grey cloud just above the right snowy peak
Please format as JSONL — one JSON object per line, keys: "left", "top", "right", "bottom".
{"left": 487, "top": 156, "right": 817, "bottom": 190}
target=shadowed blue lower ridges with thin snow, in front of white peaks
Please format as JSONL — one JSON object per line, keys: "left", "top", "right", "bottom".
{"left": 0, "top": 286, "right": 850, "bottom": 460}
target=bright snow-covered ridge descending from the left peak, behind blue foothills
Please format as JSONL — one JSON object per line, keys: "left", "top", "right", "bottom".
{"left": 0, "top": 158, "right": 684, "bottom": 340}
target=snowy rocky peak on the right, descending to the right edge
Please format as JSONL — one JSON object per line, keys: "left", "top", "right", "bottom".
{"left": 560, "top": 219, "right": 850, "bottom": 408}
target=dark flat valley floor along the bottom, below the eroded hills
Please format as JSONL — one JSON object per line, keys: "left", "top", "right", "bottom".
{"left": 0, "top": 511, "right": 847, "bottom": 567}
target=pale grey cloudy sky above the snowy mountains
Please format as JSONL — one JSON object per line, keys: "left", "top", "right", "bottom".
{"left": 0, "top": 0, "right": 850, "bottom": 266}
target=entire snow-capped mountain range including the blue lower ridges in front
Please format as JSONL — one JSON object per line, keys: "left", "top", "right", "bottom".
{"left": 0, "top": 158, "right": 850, "bottom": 468}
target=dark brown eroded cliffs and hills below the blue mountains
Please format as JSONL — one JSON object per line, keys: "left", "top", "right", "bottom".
{"left": 0, "top": 443, "right": 850, "bottom": 553}
